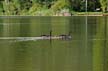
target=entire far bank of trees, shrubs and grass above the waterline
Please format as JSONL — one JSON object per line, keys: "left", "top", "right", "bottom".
{"left": 0, "top": 0, "right": 108, "bottom": 16}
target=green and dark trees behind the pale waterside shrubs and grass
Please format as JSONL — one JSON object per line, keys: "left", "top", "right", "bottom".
{"left": 0, "top": 0, "right": 108, "bottom": 15}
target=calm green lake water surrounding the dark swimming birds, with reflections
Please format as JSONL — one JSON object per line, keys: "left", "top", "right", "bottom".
{"left": 0, "top": 16, "right": 108, "bottom": 71}
